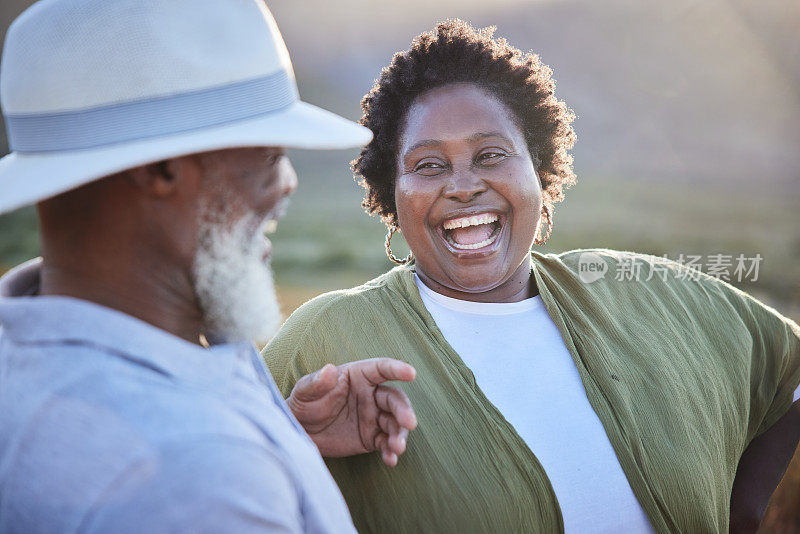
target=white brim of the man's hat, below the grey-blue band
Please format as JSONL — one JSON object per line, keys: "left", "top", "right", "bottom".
{"left": 0, "top": 101, "right": 372, "bottom": 214}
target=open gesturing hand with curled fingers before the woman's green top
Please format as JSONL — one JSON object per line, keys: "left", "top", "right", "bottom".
{"left": 286, "top": 358, "right": 417, "bottom": 467}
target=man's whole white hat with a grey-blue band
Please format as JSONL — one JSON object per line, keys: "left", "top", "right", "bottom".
{"left": 0, "top": 0, "right": 372, "bottom": 218}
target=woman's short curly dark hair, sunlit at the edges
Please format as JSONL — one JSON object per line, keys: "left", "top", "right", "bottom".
{"left": 351, "top": 19, "right": 576, "bottom": 224}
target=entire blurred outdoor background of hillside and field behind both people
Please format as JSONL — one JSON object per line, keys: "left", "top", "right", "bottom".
{"left": 0, "top": 0, "right": 800, "bottom": 319}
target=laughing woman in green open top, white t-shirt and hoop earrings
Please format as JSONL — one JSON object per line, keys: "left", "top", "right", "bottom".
{"left": 264, "top": 21, "right": 800, "bottom": 533}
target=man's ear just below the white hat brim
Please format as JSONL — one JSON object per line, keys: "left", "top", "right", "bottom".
{"left": 128, "top": 156, "right": 201, "bottom": 198}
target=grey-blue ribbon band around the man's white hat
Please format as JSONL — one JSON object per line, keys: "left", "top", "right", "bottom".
{"left": 5, "top": 70, "right": 298, "bottom": 152}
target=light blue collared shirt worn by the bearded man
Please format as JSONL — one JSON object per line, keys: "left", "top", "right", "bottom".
{"left": 0, "top": 260, "right": 354, "bottom": 534}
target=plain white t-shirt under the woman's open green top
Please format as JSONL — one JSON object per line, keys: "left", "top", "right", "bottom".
{"left": 416, "top": 277, "right": 800, "bottom": 534}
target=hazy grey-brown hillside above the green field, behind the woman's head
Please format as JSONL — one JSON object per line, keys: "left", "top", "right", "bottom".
{"left": 272, "top": 0, "right": 800, "bottom": 188}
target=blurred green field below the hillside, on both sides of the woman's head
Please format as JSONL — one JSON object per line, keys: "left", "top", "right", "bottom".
{"left": 264, "top": 151, "right": 800, "bottom": 320}
